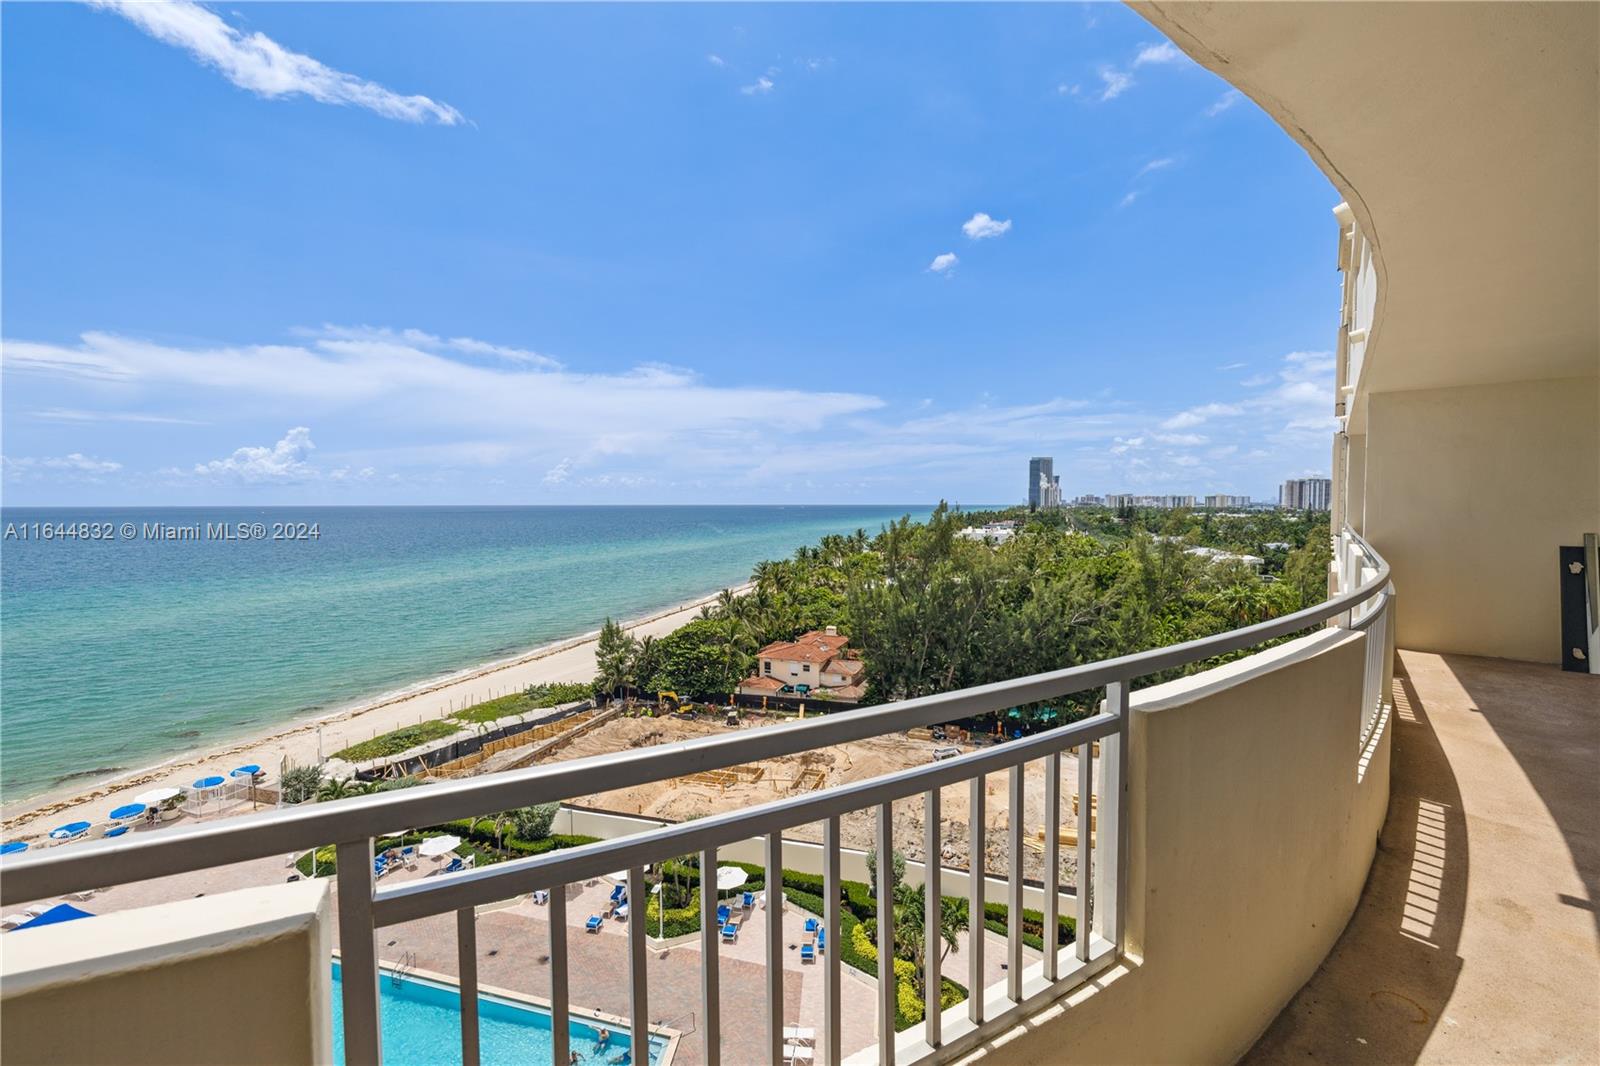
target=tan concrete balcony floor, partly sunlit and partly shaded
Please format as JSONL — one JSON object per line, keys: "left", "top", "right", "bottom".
{"left": 1243, "top": 651, "right": 1600, "bottom": 1064}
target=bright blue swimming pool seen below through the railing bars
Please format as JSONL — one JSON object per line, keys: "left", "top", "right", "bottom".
{"left": 333, "top": 962, "right": 667, "bottom": 1066}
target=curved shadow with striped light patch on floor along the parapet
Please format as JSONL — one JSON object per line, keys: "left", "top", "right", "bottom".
{"left": 1240, "top": 663, "right": 1469, "bottom": 1064}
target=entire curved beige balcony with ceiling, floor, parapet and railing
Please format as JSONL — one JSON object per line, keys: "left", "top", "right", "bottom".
{"left": 0, "top": 5, "right": 1600, "bottom": 1064}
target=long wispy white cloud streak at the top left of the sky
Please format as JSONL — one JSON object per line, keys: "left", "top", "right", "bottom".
{"left": 90, "top": 0, "right": 464, "bottom": 126}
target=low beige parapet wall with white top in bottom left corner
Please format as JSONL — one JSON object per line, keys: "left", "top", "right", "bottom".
{"left": 0, "top": 877, "right": 333, "bottom": 1066}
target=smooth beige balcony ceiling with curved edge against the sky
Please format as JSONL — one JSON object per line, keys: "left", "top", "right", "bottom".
{"left": 1131, "top": 2, "right": 1600, "bottom": 403}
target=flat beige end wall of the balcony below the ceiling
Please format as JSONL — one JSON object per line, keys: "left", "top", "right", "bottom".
{"left": 1352, "top": 378, "right": 1600, "bottom": 663}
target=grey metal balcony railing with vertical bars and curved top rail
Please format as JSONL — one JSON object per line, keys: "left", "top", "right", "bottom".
{"left": 0, "top": 530, "right": 1392, "bottom": 1066}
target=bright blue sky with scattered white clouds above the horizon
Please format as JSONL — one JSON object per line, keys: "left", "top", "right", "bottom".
{"left": 0, "top": 3, "right": 1338, "bottom": 504}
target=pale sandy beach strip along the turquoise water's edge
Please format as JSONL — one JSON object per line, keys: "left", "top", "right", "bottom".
{"left": 0, "top": 587, "right": 744, "bottom": 840}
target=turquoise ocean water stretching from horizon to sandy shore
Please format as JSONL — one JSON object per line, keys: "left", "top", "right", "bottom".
{"left": 0, "top": 506, "right": 928, "bottom": 802}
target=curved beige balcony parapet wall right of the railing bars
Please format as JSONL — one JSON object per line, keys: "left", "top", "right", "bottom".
{"left": 960, "top": 631, "right": 1389, "bottom": 1066}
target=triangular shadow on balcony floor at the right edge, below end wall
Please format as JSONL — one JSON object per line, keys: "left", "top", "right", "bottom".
{"left": 1442, "top": 655, "right": 1600, "bottom": 935}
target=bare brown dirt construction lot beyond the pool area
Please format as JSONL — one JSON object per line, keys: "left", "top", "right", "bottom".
{"left": 524, "top": 715, "right": 1077, "bottom": 884}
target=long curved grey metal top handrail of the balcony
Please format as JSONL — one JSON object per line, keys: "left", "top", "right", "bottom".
{"left": 0, "top": 527, "right": 1389, "bottom": 906}
